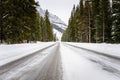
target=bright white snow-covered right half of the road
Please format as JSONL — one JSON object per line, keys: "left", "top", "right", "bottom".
{"left": 61, "top": 43, "right": 120, "bottom": 80}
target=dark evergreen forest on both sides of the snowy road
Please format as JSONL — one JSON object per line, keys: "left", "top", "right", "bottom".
{"left": 0, "top": 0, "right": 120, "bottom": 44}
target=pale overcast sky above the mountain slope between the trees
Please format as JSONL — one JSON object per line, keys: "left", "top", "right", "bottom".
{"left": 36, "top": 0, "right": 79, "bottom": 24}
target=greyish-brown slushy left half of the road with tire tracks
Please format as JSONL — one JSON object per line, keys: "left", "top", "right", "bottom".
{"left": 0, "top": 43, "right": 62, "bottom": 80}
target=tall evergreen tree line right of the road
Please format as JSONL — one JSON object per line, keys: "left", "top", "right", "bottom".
{"left": 62, "top": 0, "right": 120, "bottom": 43}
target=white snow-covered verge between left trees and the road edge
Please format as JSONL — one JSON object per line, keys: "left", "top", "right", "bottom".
{"left": 0, "top": 42, "right": 54, "bottom": 66}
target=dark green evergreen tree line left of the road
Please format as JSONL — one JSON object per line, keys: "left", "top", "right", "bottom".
{"left": 0, "top": 0, "right": 53, "bottom": 43}
